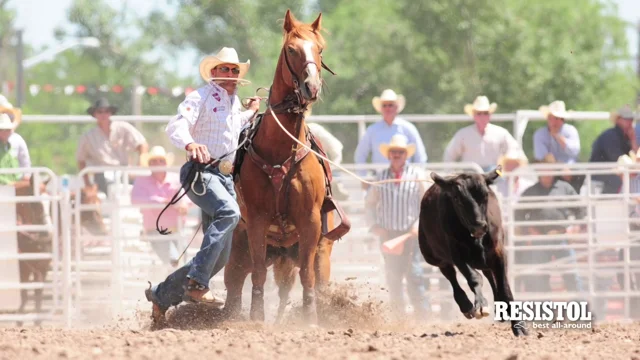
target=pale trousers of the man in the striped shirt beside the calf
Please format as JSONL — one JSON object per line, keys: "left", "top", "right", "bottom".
{"left": 383, "top": 231, "right": 429, "bottom": 318}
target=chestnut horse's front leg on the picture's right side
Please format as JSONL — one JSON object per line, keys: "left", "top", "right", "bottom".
{"left": 296, "top": 208, "right": 321, "bottom": 326}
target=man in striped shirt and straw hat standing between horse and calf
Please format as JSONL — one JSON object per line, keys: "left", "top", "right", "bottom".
{"left": 365, "top": 134, "right": 428, "bottom": 318}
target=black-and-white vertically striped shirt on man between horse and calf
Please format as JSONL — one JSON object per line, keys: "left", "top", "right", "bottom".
{"left": 367, "top": 164, "right": 427, "bottom": 231}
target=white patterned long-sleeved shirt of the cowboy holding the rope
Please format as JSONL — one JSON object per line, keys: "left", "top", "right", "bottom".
{"left": 165, "top": 81, "right": 254, "bottom": 161}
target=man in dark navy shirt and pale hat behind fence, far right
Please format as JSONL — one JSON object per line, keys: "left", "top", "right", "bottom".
{"left": 589, "top": 106, "right": 638, "bottom": 194}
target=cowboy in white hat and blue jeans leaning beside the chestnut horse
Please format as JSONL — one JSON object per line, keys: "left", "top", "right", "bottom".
{"left": 145, "top": 47, "right": 260, "bottom": 323}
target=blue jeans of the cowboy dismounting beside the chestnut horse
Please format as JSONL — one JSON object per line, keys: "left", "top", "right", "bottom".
{"left": 152, "top": 162, "right": 240, "bottom": 308}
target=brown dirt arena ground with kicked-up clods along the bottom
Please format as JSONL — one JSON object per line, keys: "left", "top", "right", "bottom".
{"left": 0, "top": 282, "right": 640, "bottom": 360}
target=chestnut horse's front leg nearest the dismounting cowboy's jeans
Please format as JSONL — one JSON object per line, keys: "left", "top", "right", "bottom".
{"left": 247, "top": 216, "right": 269, "bottom": 321}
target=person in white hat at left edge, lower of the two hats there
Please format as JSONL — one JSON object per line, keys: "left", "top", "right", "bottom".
{"left": 0, "top": 113, "right": 31, "bottom": 185}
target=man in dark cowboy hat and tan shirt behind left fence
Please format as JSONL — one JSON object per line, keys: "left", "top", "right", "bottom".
{"left": 76, "top": 98, "right": 148, "bottom": 194}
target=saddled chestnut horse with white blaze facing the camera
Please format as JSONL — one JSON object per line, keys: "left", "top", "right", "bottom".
{"left": 224, "top": 10, "right": 349, "bottom": 325}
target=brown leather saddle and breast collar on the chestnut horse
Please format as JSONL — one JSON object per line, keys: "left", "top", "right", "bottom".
{"left": 233, "top": 114, "right": 351, "bottom": 241}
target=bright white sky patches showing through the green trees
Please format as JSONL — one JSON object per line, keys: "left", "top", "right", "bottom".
{"left": 10, "top": 0, "right": 640, "bottom": 76}
